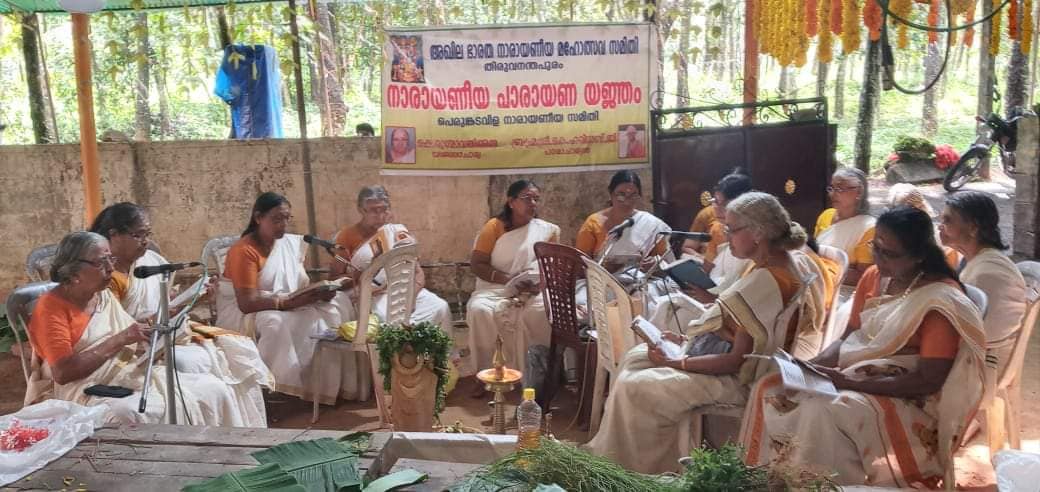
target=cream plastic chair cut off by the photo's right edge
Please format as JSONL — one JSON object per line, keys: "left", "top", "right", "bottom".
{"left": 986, "top": 261, "right": 1040, "bottom": 457}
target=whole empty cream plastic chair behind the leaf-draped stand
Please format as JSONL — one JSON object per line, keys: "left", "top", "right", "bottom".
{"left": 311, "top": 243, "right": 419, "bottom": 426}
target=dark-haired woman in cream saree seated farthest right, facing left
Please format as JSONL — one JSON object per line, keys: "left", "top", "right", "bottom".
{"left": 939, "top": 191, "right": 1025, "bottom": 373}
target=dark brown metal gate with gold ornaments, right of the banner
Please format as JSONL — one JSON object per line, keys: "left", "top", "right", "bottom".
{"left": 651, "top": 98, "right": 836, "bottom": 234}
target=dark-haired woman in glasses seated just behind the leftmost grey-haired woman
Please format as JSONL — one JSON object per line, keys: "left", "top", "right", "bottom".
{"left": 90, "top": 202, "right": 270, "bottom": 426}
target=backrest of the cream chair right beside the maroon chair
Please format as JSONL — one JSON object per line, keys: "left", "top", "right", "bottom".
{"left": 581, "top": 258, "right": 635, "bottom": 371}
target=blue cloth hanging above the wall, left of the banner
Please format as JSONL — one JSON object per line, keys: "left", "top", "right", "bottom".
{"left": 213, "top": 45, "right": 282, "bottom": 138}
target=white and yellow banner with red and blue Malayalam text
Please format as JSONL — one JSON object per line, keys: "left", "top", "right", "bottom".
{"left": 382, "top": 23, "right": 656, "bottom": 175}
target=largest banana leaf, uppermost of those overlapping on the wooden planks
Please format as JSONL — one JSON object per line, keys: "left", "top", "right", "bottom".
{"left": 253, "top": 438, "right": 361, "bottom": 492}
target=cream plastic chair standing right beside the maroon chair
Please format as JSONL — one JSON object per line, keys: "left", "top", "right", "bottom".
{"left": 582, "top": 254, "right": 636, "bottom": 436}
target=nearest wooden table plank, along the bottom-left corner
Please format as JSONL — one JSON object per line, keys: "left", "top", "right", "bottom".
{"left": 0, "top": 470, "right": 184, "bottom": 492}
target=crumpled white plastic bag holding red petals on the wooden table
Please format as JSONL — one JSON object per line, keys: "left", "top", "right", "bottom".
{"left": 0, "top": 399, "right": 108, "bottom": 485}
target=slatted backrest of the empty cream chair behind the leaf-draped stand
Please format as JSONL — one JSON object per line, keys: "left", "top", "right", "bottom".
{"left": 354, "top": 242, "right": 418, "bottom": 349}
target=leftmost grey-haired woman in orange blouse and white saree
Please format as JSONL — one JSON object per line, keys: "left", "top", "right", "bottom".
{"left": 26, "top": 232, "right": 242, "bottom": 426}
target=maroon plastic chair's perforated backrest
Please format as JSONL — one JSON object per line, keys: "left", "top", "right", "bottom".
{"left": 535, "top": 242, "right": 586, "bottom": 336}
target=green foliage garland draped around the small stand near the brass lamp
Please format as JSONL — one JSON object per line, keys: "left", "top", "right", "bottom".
{"left": 375, "top": 321, "right": 451, "bottom": 416}
